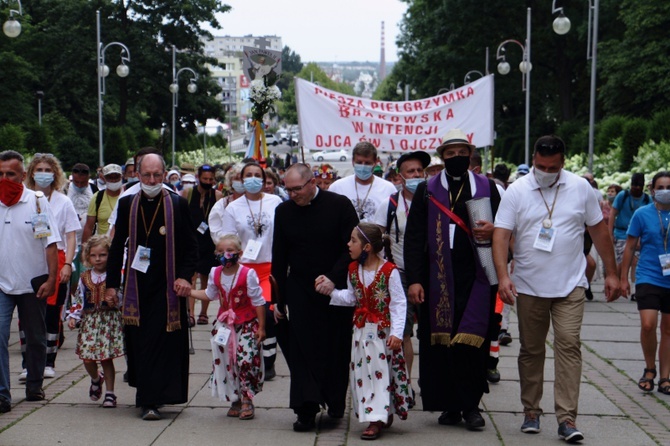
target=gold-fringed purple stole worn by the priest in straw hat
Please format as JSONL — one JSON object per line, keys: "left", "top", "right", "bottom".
{"left": 427, "top": 173, "right": 491, "bottom": 348}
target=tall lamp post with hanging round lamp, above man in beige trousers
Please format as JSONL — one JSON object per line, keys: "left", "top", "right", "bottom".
{"left": 551, "top": 0, "right": 600, "bottom": 172}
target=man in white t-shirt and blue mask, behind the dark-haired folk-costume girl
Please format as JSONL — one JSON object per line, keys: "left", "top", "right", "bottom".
{"left": 328, "top": 141, "right": 396, "bottom": 222}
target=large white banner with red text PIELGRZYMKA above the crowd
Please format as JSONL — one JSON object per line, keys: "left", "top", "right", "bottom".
{"left": 295, "top": 75, "right": 494, "bottom": 152}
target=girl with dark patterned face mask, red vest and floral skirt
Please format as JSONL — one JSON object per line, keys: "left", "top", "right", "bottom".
{"left": 191, "top": 234, "right": 265, "bottom": 420}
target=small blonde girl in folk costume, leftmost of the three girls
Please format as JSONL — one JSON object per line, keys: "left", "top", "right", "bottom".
{"left": 67, "top": 235, "right": 124, "bottom": 408}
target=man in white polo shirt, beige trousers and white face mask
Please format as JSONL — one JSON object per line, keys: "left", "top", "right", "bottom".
{"left": 493, "top": 136, "right": 619, "bottom": 443}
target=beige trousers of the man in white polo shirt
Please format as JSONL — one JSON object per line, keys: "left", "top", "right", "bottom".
{"left": 517, "top": 287, "right": 585, "bottom": 423}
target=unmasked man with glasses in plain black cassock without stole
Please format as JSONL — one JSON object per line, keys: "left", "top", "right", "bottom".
{"left": 272, "top": 164, "right": 358, "bottom": 432}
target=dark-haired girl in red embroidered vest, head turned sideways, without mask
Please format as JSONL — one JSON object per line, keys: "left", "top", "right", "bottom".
{"left": 316, "top": 223, "right": 410, "bottom": 440}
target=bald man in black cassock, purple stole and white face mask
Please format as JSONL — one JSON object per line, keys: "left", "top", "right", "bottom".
{"left": 105, "top": 154, "right": 198, "bottom": 420}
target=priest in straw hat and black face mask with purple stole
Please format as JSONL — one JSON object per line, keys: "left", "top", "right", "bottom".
{"left": 404, "top": 129, "right": 500, "bottom": 430}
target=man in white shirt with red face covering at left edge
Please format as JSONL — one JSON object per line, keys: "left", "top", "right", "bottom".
{"left": 0, "top": 150, "right": 61, "bottom": 413}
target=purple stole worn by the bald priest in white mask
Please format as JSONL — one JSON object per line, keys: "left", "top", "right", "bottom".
{"left": 123, "top": 189, "right": 181, "bottom": 332}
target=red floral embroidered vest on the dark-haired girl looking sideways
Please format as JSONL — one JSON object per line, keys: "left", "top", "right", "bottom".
{"left": 349, "top": 262, "right": 396, "bottom": 328}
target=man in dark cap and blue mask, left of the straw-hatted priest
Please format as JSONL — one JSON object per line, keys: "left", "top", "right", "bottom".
{"left": 373, "top": 151, "right": 430, "bottom": 409}
